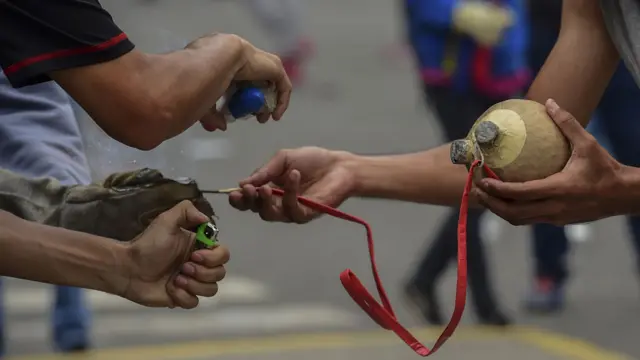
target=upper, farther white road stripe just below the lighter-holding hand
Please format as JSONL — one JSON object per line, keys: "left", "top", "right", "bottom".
{"left": 3, "top": 276, "right": 271, "bottom": 315}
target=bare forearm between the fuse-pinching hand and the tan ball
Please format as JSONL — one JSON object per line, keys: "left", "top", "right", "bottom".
{"left": 345, "top": 144, "right": 475, "bottom": 206}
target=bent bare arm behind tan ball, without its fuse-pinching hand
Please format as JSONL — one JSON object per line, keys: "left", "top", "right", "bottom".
{"left": 344, "top": 0, "right": 619, "bottom": 205}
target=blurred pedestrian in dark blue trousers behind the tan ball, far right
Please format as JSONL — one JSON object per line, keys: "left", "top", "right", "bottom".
{"left": 525, "top": 0, "right": 640, "bottom": 313}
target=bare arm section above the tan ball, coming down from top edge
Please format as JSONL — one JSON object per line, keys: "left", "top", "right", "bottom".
{"left": 526, "top": 0, "right": 619, "bottom": 126}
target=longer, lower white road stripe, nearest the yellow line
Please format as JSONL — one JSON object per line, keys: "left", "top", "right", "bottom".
{"left": 7, "top": 304, "right": 359, "bottom": 343}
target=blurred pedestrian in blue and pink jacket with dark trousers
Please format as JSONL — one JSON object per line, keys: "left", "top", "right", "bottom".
{"left": 404, "top": 0, "right": 529, "bottom": 326}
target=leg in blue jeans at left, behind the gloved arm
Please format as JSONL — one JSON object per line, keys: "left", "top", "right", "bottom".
{"left": 0, "top": 73, "right": 91, "bottom": 351}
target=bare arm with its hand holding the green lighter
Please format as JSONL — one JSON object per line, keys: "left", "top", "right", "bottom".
{"left": 0, "top": 201, "right": 229, "bottom": 308}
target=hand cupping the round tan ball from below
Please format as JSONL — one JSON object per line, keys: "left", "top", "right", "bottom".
{"left": 474, "top": 100, "right": 636, "bottom": 225}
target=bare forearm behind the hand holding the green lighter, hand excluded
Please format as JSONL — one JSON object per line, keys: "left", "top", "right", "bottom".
{"left": 0, "top": 211, "right": 129, "bottom": 294}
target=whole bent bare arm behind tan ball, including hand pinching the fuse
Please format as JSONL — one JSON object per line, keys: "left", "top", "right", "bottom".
{"left": 230, "top": 0, "right": 618, "bottom": 220}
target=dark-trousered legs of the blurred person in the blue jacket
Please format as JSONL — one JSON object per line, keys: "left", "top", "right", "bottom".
{"left": 407, "top": 87, "right": 508, "bottom": 325}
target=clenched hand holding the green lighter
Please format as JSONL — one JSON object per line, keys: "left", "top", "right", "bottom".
{"left": 122, "top": 201, "right": 229, "bottom": 309}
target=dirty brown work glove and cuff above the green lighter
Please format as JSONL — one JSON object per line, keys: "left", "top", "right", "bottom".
{"left": 0, "top": 168, "right": 214, "bottom": 241}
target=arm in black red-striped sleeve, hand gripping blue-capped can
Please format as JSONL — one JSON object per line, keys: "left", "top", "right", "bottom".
{"left": 0, "top": 0, "right": 291, "bottom": 150}
